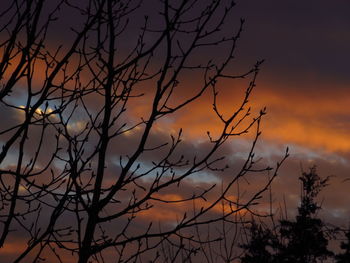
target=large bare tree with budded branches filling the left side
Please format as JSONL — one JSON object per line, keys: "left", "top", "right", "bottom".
{"left": 0, "top": 0, "right": 287, "bottom": 263}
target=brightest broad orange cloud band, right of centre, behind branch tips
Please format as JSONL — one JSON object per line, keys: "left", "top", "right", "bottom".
{"left": 127, "top": 80, "right": 350, "bottom": 153}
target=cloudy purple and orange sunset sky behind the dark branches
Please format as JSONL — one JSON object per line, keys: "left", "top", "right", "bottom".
{"left": 0, "top": 0, "right": 350, "bottom": 262}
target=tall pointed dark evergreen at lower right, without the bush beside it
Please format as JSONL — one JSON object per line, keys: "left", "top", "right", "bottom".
{"left": 277, "top": 167, "right": 333, "bottom": 263}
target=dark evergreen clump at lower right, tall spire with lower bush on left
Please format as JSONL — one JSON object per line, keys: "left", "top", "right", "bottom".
{"left": 241, "top": 166, "right": 336, "bottom": 263}
